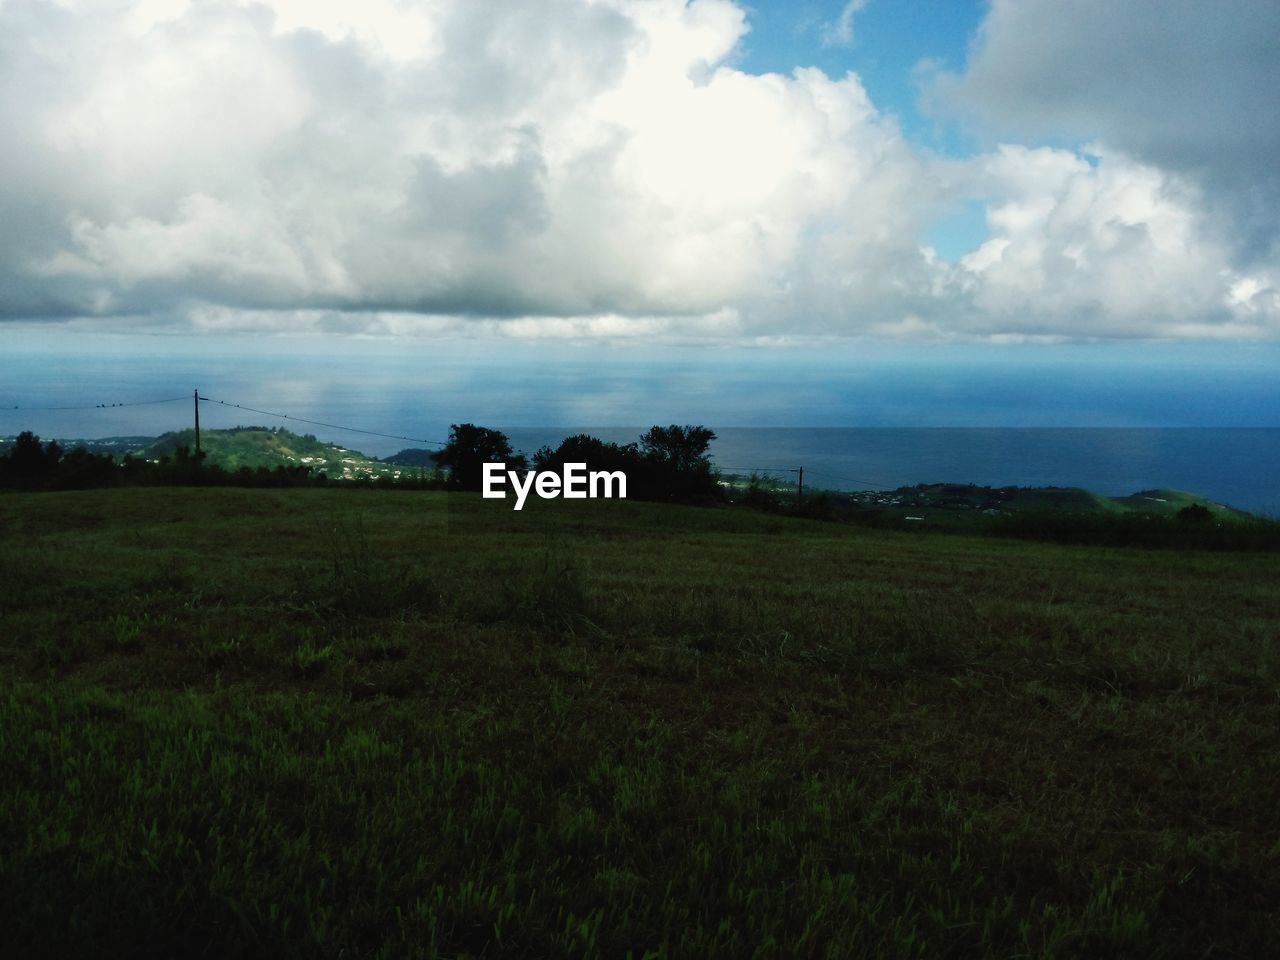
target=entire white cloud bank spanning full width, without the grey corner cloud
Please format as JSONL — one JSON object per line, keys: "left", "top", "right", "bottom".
{"left": 0, "top": 0, "right": 1280, "bottom": 342}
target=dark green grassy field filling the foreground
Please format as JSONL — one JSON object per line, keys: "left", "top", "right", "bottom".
{"left": 0, "top": 489, "right": 1280, "bottom": 960}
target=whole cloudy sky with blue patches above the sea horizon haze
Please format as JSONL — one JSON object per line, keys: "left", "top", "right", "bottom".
{"left": 0, "top": 0, "right": 1280, "bottom": 346}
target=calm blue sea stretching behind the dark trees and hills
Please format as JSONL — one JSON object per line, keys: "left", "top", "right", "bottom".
{"left": 0, "top": 333, "right": 1280, "bottom": 515}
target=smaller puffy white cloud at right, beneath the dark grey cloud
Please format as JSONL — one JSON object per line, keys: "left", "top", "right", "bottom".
{"left": 957, "top": 146, "right": 1261, "bottom": 337}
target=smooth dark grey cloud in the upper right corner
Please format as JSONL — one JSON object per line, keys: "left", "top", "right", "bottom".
{"left": 928, "top": 0, "right": 1280, "bottom": 257}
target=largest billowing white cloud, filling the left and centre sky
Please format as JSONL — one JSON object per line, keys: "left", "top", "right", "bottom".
{"left": 5, "top": 0, "right": 931, "bottom": 323}
